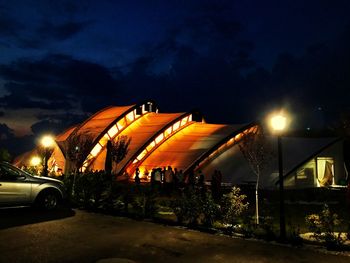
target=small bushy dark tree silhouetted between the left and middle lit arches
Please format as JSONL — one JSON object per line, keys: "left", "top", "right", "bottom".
{"left": 105, "top": 135, "right": 131, "bottom": 174}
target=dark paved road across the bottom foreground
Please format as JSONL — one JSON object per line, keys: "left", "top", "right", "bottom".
{"left": 0, "top": 209, "right": 350, "bottom": 263}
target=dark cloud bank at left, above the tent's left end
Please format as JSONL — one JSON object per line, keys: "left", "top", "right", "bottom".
{"left": 0, "top": 55, "right": 120, "bottom": 111}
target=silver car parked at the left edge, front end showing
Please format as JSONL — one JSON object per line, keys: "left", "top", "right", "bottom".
{"left": 0, "top": 162, "right": 66, "bottom": 210}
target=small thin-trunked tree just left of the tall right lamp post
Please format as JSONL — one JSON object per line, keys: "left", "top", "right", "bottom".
{"left": 238, "top": 128, "right": 272, "bottom": 225}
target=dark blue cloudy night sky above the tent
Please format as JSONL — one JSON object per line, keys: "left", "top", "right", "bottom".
{"left": 0, "top": 0, "right": 350, "bottom": 154}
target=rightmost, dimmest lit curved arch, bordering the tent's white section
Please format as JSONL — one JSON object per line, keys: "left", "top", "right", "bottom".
{"left": 184, "top": 123, "right": 258, "bottom": 173}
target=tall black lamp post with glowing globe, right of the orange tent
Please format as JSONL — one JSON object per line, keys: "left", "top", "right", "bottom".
{"left": 271, "top": 114, "right": 287, "bottom": 242}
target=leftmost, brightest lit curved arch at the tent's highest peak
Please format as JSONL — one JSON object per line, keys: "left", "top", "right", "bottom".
{"left": 80, "top": 101, "right": 158, "bottom": 171}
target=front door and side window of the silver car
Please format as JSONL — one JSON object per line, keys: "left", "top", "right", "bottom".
{"left": 0, "top": 164, "right": 32, "bottom": 205}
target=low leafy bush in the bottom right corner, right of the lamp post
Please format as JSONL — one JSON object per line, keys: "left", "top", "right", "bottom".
{"left": 306, "top": 205, "right": 345, "bottom": 250}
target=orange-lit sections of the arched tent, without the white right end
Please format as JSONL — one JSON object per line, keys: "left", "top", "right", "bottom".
{"left": 15, "top": 101, "right": 257, "bottom": 175}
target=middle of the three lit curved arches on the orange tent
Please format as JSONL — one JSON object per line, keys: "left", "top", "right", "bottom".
{"left": 120, "top": 111, "right": 198, "bottom": 177}
